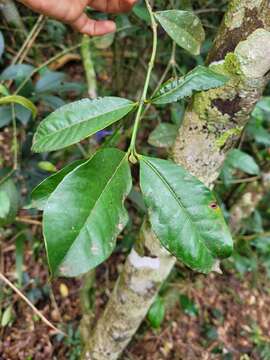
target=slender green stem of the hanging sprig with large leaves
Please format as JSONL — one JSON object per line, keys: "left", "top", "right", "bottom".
{"left": 129, "top": 0, "right": 157, "bottom": 162}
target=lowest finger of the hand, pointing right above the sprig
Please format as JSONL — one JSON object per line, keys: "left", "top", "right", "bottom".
{"left": 71, "top": 14, "right": 116, "bottom": 36}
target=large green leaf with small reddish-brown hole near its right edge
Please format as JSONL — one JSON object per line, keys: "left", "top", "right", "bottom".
{"left": 140, "top": 156, "right": 233, "bottom": 273}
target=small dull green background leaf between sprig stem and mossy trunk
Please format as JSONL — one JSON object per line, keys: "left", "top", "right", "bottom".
{"left": 148, "top": 123, "right": 178, "bottom": 148}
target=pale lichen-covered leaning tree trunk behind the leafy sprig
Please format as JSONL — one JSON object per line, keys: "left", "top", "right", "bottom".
{"left": 83, "top": 0, "right": 270, "bottom": 360}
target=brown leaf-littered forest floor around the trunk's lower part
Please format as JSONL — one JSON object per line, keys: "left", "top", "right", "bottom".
{"left": 0, "top": 235, "right": 270, "bottom": 360}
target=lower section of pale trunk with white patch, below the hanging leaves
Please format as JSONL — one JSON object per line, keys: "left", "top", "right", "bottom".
{"left": 83, "top": 222, "right": 175, "bottom": 360}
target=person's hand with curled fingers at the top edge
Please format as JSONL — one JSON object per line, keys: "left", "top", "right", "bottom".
{"left": 19, "top": 0, "right": 137, "bottom": 36}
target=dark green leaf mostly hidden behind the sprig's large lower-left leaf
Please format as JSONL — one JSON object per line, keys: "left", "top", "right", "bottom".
{"left": 30, "top": 160, "right": 83, "bottom": 210}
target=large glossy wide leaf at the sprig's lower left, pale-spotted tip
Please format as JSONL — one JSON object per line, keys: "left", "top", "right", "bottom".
{"left": 43, "top": 149, "right": 132, "bottom": 276}
